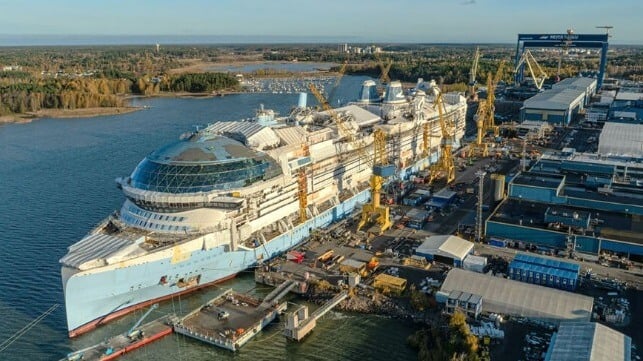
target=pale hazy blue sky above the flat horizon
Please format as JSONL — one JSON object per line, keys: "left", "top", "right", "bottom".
{"left": 0, "top": 0, "right": 643, "bottom": 45}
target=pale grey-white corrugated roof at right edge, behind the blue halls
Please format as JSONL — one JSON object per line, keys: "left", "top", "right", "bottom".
{"left": 598, "top": 122, "right": 643, "bottom": 158}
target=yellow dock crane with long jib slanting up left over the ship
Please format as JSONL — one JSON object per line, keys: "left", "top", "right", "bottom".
{"left": 308, "top": 83, "right": 395, "bottom": 232}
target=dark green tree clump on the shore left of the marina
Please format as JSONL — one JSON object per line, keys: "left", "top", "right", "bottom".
{"left": 161, "top": 73, "right": 239, "bottom": 93}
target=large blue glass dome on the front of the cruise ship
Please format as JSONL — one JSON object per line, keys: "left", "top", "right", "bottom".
{"left": 128, "top": 134, "right": 281, "bottom": 193}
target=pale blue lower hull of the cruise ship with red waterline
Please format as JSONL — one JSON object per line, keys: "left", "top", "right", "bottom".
{"left": 61, "top": 191, "right": 370, "bottom": 337}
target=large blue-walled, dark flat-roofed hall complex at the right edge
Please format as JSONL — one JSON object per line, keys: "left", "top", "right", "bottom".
{"left": 486, "top": 151, "right": 643, "bottom": 260}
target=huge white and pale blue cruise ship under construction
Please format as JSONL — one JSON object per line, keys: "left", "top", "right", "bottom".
{"left": 60, "top": 81, "right": 467, "bottom": 337}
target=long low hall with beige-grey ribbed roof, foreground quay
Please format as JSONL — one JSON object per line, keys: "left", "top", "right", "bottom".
{"left": 440, "top": 268, "right": 594, "bottom": 324}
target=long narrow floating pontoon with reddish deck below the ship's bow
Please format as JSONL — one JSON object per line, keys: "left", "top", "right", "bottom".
{"left": 62, "top": 315, "right": 176, "bottom": 361}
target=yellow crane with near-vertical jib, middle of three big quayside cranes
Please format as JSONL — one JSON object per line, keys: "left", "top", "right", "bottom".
{"left": 429, "top": 92, "right": 455, "bottom": 184}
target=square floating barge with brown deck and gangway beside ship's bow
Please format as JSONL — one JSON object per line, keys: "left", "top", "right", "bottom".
{"left": 174, "top": 284, "right": 292, "bottom": 351}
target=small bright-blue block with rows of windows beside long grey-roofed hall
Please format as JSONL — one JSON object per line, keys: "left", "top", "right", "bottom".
{"left": 509, "top": 253, "right": 580, "bottom": 291}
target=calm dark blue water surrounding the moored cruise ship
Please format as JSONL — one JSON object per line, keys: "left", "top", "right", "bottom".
{"left": 0, "top": 77, "right": 416, "bottom": 360}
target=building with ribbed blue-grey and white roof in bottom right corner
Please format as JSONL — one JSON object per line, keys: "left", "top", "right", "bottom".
{"left": 545, "top": 322, "right": 632, "bottom": 361}
